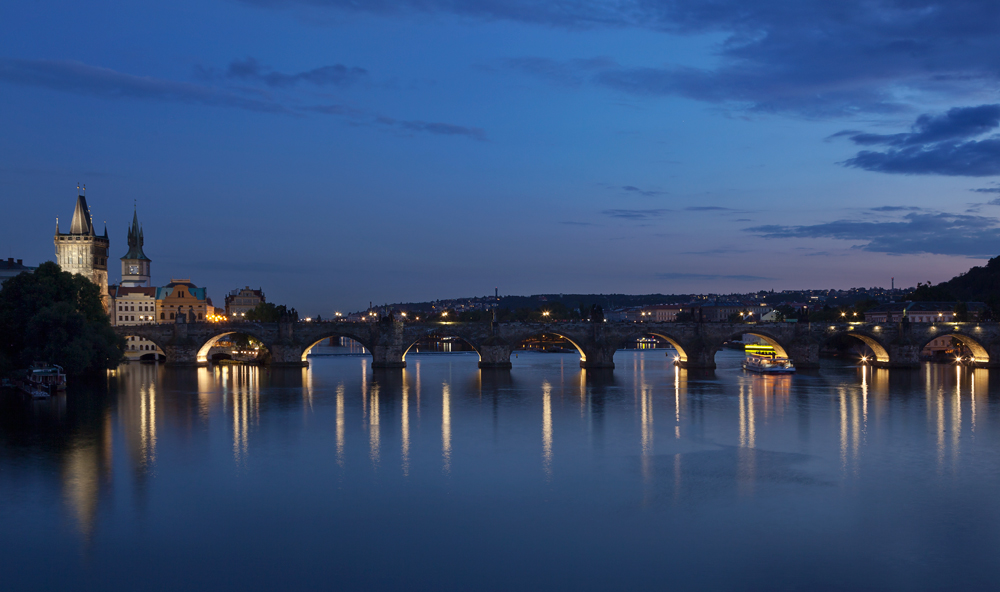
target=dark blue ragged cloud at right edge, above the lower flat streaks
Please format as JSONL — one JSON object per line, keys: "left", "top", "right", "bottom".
{"left": 834, "top": 105, "right": 1000, "bottom": 177}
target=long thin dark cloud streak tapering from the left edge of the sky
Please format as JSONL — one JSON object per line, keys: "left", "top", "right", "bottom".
{"left": 0, "top": 58, "right": 291, "bottom": 113}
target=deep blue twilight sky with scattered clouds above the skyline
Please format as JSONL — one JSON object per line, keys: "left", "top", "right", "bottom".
{"left": 0, "top": 0, "right": 1000, "bottom": 315}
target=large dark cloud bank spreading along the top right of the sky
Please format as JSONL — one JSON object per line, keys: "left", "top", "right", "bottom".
{"left": 462, "top": 0, "right": 1000, "bottom": 116}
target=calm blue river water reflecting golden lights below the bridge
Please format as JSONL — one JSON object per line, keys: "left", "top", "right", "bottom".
{"left": 0, "top": 350, "right": 1000, "bottom": 591}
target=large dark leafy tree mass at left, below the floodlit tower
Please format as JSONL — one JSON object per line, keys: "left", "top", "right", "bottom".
{"left": 0, "top": 261, "right": 125, "bottom": 376}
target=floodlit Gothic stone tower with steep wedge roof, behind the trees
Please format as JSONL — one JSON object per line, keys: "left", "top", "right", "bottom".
{"left": 53, "top": 188, "right": 110, "bottom": 309}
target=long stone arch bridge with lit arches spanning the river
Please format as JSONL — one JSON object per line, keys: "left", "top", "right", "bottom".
{"left": 115, "top": 320, "right": 1000, "bottom": 369}
